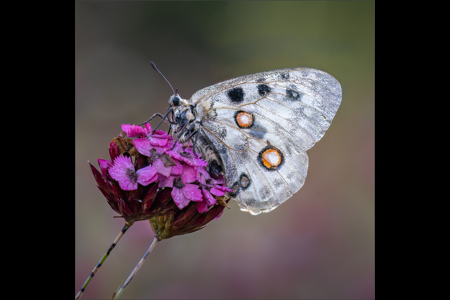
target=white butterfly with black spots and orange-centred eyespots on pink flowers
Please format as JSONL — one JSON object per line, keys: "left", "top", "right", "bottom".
{"left": 144, "top": 62, "right": 342, "bottom": 215}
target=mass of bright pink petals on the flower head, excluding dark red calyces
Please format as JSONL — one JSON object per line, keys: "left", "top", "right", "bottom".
{"left": 116, "top": 123, "right": 231, "bottom": 213}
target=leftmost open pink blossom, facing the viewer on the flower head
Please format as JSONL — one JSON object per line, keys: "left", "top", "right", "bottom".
{"left": 108, "top": 155, "right": 158, "bottom": 191}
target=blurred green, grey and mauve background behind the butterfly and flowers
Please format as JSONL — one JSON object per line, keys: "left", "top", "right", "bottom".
{"left": 75, "top": 1, "right": 375, "bottom": 299}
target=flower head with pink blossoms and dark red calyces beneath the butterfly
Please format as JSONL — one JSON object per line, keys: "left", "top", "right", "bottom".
{"left": 91, "top": 124, "right": 231, "bottom": 227}
